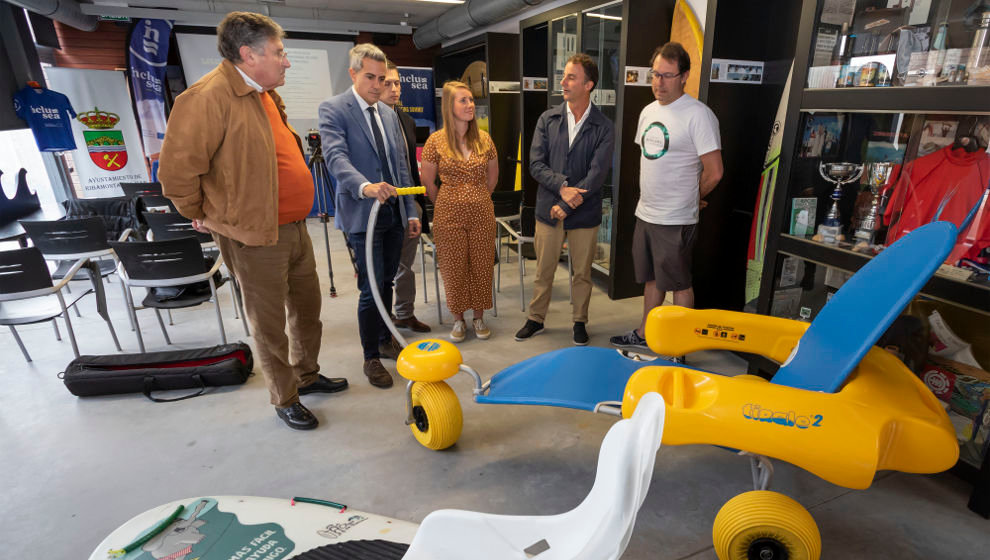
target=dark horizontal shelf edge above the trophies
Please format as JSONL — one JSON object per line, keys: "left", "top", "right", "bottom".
{"left": 801, "top": 86, "right": 990, "bottom": 114}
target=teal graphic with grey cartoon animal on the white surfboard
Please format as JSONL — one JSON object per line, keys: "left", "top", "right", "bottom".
{"left": 124, "top": 498, "right": 295, "bottom": 560}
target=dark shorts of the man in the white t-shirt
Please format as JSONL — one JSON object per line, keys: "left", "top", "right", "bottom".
{"left": 632, "top": 218, "right": 697, "bottom": 292}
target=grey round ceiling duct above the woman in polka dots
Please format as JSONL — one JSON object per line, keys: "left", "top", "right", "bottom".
{"left": 413, "top": 0, "right": 543, "bottom": 49}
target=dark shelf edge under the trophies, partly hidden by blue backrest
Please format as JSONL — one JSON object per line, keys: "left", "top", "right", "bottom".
{"left": 777, "top": 233, "right": 990, "bottom": 315}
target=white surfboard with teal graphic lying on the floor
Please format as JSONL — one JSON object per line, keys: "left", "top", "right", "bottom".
{"left": 90, "top": 496, "right": 418, "bottom": 560}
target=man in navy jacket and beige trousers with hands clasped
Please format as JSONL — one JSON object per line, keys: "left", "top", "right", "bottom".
{"left": 516, "top": 53, "right": 615, "bottom": 346}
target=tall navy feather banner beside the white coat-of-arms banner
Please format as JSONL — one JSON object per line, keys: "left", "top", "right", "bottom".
{"left": 128, "top": 19, "right": 172, "bottom": 160}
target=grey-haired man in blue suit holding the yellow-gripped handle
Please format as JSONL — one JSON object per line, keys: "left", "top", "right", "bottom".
{"left": 320, "top": 43, "right": 420, "bottom": 389}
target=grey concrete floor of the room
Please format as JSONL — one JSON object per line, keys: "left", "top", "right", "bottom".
{"left": 0, "top": 222, "right": 990, "bottom": 560}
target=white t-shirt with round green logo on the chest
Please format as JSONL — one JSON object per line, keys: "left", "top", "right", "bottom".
{"left": 636, "top": 94, "right": 722, "bottom": 225}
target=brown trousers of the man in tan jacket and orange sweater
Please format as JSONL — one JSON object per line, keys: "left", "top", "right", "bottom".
{"left": 213, "top": 220, "right": 323, "bottom": 407}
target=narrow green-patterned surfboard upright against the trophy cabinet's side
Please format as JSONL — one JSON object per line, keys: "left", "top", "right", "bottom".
{"left": 745, "top": 63, "right": 794, "bottom": 310}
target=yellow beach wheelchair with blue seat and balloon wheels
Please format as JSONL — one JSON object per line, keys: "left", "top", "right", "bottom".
{"left": 368, "top": 190, "right": 959, "bottom": 560}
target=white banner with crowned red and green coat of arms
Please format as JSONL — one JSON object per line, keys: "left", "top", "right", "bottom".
{"left": 45, "top": 68, "right": 148, "bottom": 198}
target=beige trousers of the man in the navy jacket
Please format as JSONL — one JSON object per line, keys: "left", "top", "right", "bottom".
{"left": 529, "top": 220, "right": 598, "bottom": 323}
